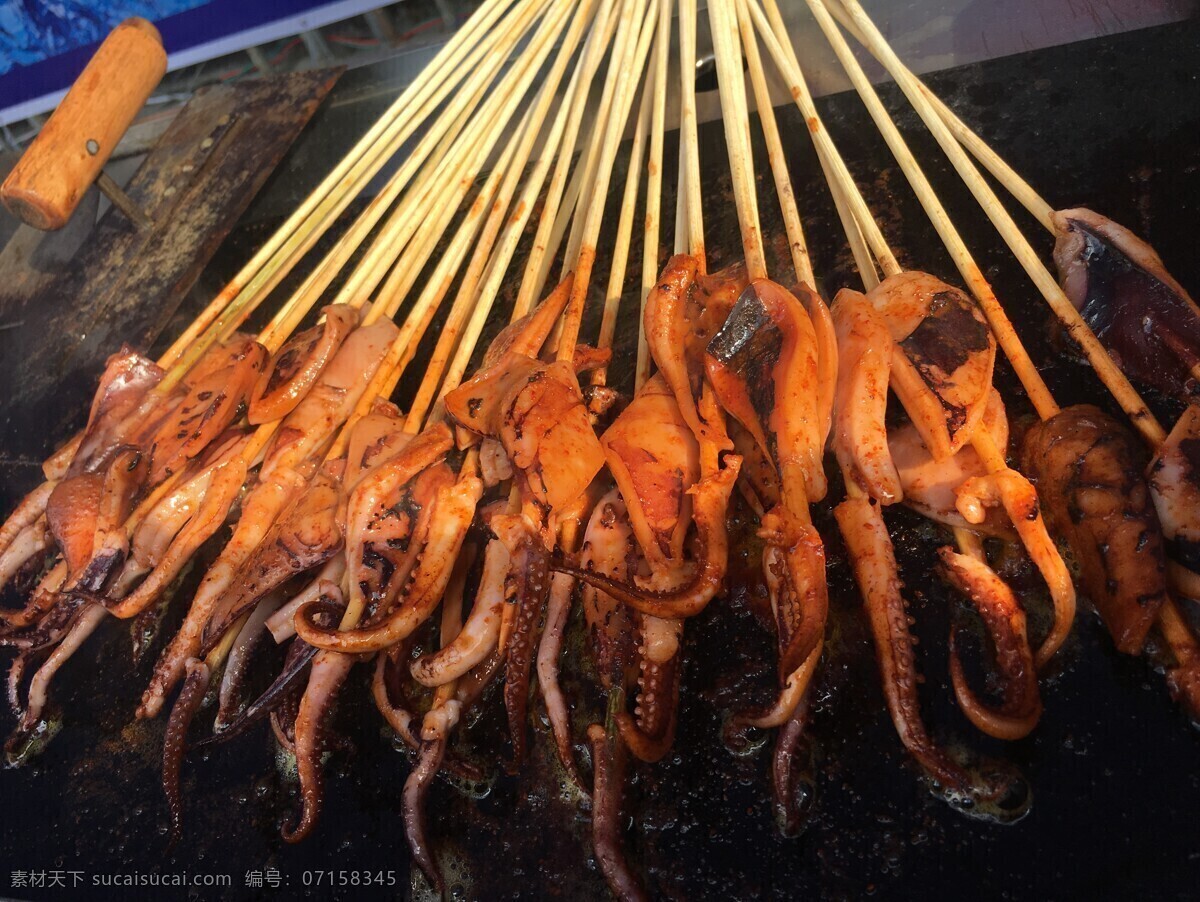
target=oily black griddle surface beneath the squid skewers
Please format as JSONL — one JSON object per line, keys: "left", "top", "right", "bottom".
{"left": 0, "top": 15, "right": 1200, "bottom": 900}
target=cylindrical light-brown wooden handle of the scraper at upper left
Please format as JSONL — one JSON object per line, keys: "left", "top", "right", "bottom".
{"left": 0, "top": 18, "right": 167, "bottom": 229}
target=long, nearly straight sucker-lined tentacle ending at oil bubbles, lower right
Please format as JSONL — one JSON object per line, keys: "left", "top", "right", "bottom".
{"left": 834, "top": 498, "right": 971, "bottom": 792}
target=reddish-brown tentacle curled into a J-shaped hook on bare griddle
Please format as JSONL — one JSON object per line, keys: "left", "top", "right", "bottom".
{"left": 938, "top": 548, "right": 1042, "bottom": 740}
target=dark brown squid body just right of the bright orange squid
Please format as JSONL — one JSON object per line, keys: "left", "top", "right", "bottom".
{"left": 1021, "top": 404, "right": 1168, "bottom": 655}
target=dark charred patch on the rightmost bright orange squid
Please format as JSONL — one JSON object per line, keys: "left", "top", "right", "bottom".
{"left": 900, "top": 290, "right": 989, "bottom": 439}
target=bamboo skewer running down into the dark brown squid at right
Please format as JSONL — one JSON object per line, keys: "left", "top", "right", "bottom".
{"left": 808, "top": 0, "right": 1060, "bottom": 420}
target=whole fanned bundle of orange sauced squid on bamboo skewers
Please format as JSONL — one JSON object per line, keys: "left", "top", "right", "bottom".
{"left": 0, "top": 0, "right": 1200, "bottom": 898}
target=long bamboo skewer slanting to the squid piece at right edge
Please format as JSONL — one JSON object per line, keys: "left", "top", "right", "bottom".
{"left": 844, "top": 0, "right": 1166, "bottom": 445}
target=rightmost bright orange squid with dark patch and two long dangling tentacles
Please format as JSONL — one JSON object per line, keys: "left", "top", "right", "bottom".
{"left": 833, "top": 272, "right": 1042, "bottom": 753}
